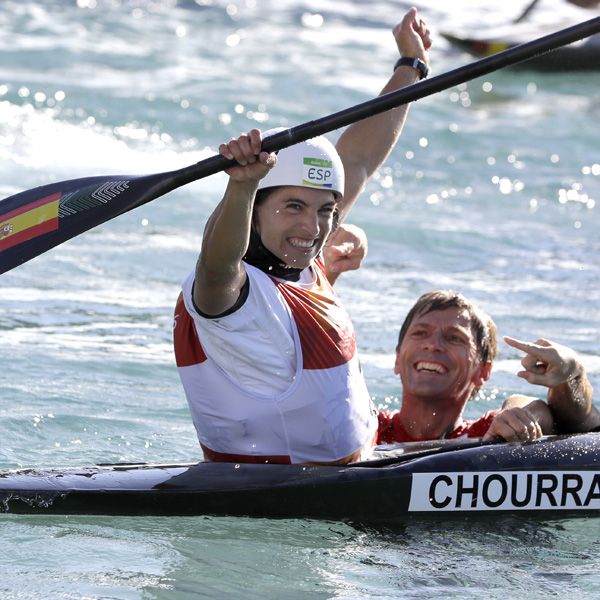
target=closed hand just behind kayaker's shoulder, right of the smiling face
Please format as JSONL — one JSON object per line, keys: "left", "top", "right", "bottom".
{"left": 323, "top": 223, "right": 368, "bottom": 285}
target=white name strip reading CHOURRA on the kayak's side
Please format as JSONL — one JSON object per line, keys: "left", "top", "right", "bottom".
{"left": 408, "top": 471, "right": 600, "bottom": 512}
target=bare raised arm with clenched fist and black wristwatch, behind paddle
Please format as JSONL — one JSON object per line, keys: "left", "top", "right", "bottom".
{"left": 336, "top": 8, "right": 431, "bottom": 222}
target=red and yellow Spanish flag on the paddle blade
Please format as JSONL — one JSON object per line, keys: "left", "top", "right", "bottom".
{"left": 0, "top": 192, "right": 61, "bottom": 251}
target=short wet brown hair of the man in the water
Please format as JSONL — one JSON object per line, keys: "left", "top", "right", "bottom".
{"left": 396, "top": 290, "right": 498, "bottom": 363}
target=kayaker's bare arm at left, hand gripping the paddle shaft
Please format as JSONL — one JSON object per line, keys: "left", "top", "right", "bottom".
{"left": 194, "top": 129, "right": 276, "bottom": 315}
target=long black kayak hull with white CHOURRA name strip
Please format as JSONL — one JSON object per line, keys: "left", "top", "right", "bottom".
{"left": 0, "top": 433, "right": 600, "bottom": 523}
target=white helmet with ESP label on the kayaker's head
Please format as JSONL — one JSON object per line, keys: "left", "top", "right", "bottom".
{"left": 258, "top": 127, "right": 344, "bottom": 196}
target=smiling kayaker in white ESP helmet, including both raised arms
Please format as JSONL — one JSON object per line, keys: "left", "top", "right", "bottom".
{"left": 174, "top": 8, "right": 431, "bottom": 463}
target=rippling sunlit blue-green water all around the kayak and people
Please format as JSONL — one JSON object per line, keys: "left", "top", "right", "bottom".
{"left": 0, "top": 0, "right": 600, "bottom": 599}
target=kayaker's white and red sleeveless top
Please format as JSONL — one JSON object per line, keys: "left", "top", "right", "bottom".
{"left": 174, "top": 261, "right": 377, "bottom": 463}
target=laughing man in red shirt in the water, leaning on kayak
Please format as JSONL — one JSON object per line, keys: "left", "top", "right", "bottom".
{"left": 378, "top": 291, "right": 600, "bottom": 443}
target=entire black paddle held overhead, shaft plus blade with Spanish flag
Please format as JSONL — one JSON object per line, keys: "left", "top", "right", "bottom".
{"left": 0, "top": 17, "right": 600, "bottom": 274}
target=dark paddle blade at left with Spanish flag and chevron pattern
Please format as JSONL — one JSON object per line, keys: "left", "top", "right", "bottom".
{"left": 0, "top": 171, "right": 179, "bottom": 274}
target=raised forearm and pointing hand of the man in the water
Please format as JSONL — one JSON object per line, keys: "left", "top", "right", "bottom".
{"left": 504, "top": 337, "right": 600, "bottom": 433}
